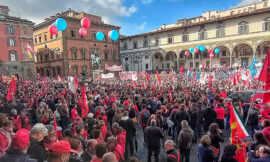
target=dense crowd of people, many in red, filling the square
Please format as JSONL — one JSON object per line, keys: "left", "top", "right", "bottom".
{"left": 0, "top": 72, "right": 270, "bottom": 162}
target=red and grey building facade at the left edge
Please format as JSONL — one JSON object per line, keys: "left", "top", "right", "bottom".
{"left": 0, "top": 5, "right": 35, "bottom": 79}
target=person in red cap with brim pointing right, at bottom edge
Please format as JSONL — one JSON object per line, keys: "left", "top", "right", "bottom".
{"left": 47, "top": 140, "right": 77, "bottom": 162}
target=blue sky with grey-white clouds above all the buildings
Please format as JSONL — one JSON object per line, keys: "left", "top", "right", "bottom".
{"left": 0, "top": 0, "right": 259, "bottom": 35}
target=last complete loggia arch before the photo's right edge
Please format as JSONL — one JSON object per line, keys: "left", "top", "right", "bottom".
{"left": 232, "top": 43, "right": 253, "bottom": 66}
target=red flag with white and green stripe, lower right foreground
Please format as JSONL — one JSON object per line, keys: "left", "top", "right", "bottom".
{"left": 230, "top": 105, "right": 249, "bottom": 162}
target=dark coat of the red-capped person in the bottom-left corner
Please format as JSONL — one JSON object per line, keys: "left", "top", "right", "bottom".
{"left": 0, "top": 149, "right": 37, "bottom": 162}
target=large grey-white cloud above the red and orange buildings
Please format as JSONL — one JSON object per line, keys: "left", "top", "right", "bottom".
{"left": 0, "top": 0, "right": 137, "bottom": 23}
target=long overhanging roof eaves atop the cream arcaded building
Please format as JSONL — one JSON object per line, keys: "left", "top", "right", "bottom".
{"left": 122, "top": 8, "right": 270, "bottom": 39}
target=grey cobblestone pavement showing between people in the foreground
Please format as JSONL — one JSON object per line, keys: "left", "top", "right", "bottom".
{"left": 134, "top": 127, "right": 229, "bottom": 162}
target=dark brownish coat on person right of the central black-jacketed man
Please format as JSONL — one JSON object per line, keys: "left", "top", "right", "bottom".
{"left": 178, "top": 127, "right": 194, "bottom": 149}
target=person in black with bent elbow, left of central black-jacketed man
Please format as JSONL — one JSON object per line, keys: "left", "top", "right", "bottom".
{"left": 119, "top": 111, "right": 136, "bottom": 159}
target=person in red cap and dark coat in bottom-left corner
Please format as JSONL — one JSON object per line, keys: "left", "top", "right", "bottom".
{"left": 0, "top": 129, "right": 37, "bottom": 162}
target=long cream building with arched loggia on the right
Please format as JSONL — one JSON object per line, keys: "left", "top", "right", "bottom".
{"left": 120, "top": 0, "right": 270, "bottom": 72}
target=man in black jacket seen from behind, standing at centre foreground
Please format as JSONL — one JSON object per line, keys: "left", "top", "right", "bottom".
{"left": 144, "top": 120, "right": 164, "bottom": 162}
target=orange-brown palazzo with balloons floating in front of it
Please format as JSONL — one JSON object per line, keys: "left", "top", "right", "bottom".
{"left": 33, "top": 9, "right": 120, "bottom": 77}
